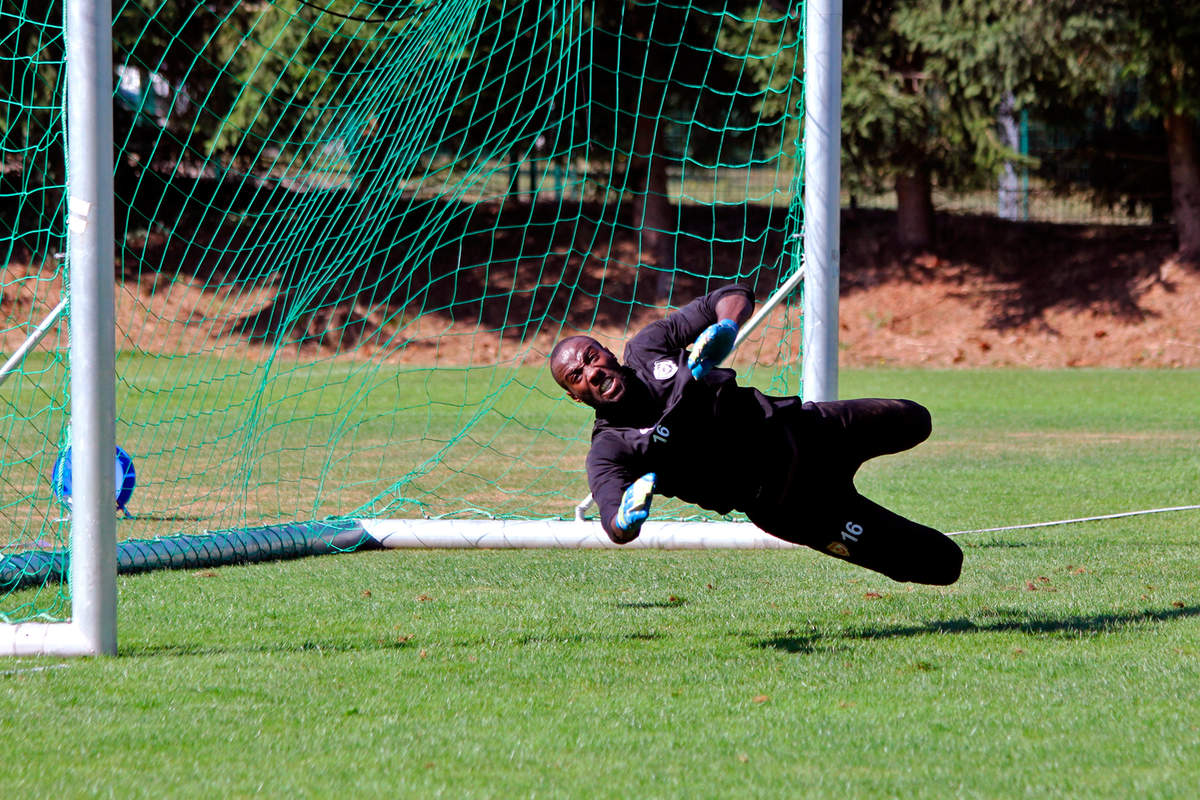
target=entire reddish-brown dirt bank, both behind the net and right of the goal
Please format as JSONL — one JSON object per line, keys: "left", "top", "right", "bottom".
{"left": 0, "top": 209, "right": 1200, "bottom": 367}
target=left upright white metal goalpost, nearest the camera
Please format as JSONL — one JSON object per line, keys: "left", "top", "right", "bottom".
{"left": 65, "top": 0, "right": 116, "bottom": 655}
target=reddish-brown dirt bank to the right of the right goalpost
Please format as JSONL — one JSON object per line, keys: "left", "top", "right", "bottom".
{"left": 840, "top": 209, "right": 1200, "bottom": 367}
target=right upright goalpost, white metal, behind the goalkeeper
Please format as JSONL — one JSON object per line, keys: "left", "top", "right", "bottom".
{"left": 803, "top": 0, "right": 841, "bottom": 401}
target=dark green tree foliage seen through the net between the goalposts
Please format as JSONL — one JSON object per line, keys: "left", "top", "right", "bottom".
{"left": 105, "top": 0, "right": 799, "bottom": 181}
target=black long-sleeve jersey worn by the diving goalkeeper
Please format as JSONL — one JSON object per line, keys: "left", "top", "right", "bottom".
{"left": 587, "top": 285, "right": 800, "bottom": 542}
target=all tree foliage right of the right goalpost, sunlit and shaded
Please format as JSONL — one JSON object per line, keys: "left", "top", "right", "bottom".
{"left": 842, "top": 0, "right": 1200, "bottom": 206}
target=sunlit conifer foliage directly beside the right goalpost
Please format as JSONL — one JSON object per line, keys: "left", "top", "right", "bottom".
{"left": 842, "top": 0, "right": 1103, "bottom": 187}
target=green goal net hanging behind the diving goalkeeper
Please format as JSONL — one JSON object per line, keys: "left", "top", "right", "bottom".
{"left": 0, "top": 0, "right": 803, "bottom": 621}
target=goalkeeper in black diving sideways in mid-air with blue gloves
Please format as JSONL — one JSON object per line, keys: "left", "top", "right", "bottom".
{"left": 550, "top": 285, "right": 962, "bottom": 584}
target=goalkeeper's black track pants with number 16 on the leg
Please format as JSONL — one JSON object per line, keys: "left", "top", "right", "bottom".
{"left": 749, "top": 398, "right": 962, "bottom": 584}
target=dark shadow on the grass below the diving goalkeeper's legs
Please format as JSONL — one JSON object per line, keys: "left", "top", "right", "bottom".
{"left": 756, "top": 606, "right": 1200, "bottom": 652}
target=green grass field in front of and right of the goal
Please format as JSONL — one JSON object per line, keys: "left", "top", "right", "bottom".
{"left": 0, "top": 371, "right": 1200, "bottom": 798}
